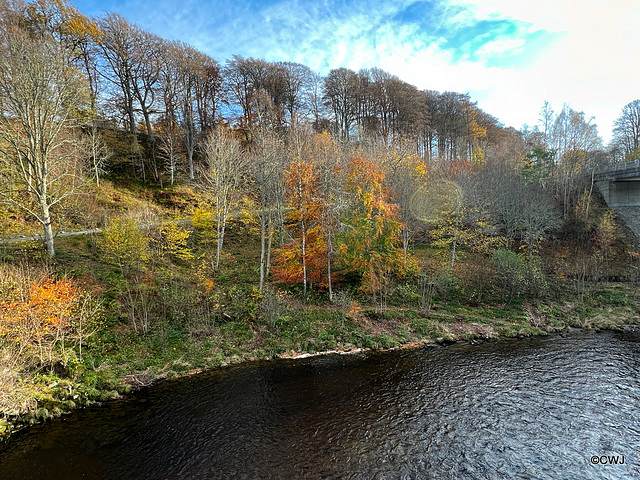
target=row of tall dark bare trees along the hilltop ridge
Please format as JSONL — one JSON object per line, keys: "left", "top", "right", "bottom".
{"left": 4, "top": 0, "right": 503, "bottom": 181}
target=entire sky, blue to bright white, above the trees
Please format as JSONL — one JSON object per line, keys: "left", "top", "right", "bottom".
{"left": 70, "top": 0, "right": 640, "bottom": 144}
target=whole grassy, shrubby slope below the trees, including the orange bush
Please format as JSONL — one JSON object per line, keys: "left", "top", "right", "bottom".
{"left": 0, "top": 182, "right": 640, "bottom": 438}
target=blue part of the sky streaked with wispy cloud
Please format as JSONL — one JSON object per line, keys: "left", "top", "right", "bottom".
{"left": 75, "top": 0, "right": 544, "bottom": 77}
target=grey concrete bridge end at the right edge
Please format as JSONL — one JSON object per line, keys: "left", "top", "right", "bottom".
{"left": 594, "top": 160, "right": 640, "bottom": 239}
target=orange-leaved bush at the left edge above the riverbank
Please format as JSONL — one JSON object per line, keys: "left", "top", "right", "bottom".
{"left": 0, "top": 267, "right": 101, "bottom": 368}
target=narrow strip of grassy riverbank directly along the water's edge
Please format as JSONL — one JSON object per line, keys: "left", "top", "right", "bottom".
{"left": 0, "top": 284, "right": 640, "bottom": 439}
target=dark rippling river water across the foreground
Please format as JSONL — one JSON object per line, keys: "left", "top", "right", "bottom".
{"left": 0, "top": 333, "right": 640, "bottom": 480}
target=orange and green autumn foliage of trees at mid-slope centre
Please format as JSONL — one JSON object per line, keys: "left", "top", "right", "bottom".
{"left": 274, "top": 146, "right": 415, "bottom": 312}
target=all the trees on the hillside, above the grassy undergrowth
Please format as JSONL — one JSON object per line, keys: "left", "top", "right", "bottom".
{"left": 0, "top": 0, "right": 637, "bottom": 275}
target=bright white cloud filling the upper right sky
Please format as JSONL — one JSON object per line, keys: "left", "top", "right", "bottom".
{"left": 442, "top": 0, "right": 640, "bottom": 140}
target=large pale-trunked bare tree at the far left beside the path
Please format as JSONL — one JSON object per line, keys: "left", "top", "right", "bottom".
{"left": 0, "top": 20, "right": 90, "bottom": 257}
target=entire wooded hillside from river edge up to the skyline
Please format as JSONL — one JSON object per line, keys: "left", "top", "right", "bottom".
{"left": 0, "top": 0, "right": 640, "bottom": 434}
